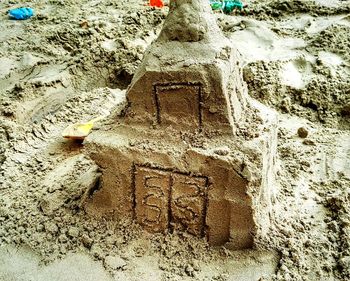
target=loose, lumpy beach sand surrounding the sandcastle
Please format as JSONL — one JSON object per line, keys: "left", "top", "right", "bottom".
{"left": 0, "top": 0, "right": 350, "bottom": 281}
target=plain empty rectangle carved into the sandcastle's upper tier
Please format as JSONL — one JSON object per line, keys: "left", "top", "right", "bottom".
{"left": 155, "top": 83, "right": 202, "bottom": 129}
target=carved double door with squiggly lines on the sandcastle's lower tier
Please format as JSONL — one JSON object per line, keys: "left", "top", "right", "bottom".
{"left": 133, "top": 165, "right": 209, "bottom": 237}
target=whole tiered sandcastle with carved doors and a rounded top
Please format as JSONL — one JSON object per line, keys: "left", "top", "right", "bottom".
{"left": 85, "top": 0, "right": 276, "bottom": 249}
